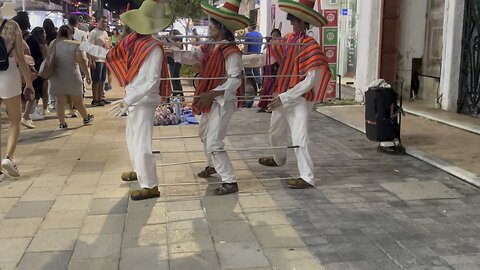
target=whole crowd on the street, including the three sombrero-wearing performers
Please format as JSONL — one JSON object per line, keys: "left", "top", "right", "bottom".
{"left": 0, "top": 0, "right": 332, "bottom": 200}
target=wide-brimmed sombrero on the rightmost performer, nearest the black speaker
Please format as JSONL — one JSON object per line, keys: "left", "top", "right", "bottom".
{"left": 278, "top": 0, "right": 328, "bottom": 27}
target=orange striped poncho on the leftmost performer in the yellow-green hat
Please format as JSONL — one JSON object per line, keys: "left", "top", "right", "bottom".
{"left": 105, "top": 33, "right": 172, "bottom": 100}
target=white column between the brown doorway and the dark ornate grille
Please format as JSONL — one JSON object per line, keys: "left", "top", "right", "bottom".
{"left": 440, "top": 0, "right": 465, "bottom": 111}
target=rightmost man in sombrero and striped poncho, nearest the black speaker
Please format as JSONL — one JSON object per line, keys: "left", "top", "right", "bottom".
{"left": 243, "top": 0, "right": 332, "bottom": 188}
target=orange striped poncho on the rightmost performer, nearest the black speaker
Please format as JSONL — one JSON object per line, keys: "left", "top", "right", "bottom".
{"left": 270, "top": 33, "right": 332, "bottom": 102}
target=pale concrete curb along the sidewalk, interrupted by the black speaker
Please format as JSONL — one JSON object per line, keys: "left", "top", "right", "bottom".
{"left": 317, "top": 108, "right": 480, "bottom": 187}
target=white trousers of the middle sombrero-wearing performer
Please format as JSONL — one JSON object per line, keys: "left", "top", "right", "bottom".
{"left": 199, "top": 101, "right": 237, "bottom": 183}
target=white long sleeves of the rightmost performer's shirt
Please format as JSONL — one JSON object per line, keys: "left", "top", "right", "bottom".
{"left": 242, "top": 54, "right": 323, "bottom": 106}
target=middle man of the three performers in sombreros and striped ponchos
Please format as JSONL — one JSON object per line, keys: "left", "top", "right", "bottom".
{"left": 175, "top": 0, "right": 251, "bottom": 195}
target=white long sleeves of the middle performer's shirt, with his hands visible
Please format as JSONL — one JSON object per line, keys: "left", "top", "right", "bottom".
{"left": 175, "top": 43, "right": 243, "bottom": 106}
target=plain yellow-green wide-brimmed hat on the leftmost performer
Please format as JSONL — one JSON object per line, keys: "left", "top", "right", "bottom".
{"left": 120, "top": 0, "right": 173, "bottom": 35}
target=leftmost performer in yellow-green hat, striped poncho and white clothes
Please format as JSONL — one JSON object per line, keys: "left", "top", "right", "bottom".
{"left": 80, "top": 0, "right": 173, "bottom": 200}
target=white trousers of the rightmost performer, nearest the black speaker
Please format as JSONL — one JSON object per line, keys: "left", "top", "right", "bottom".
{"left": 270, "top": 97, "right": 315, "bottom": 185}
